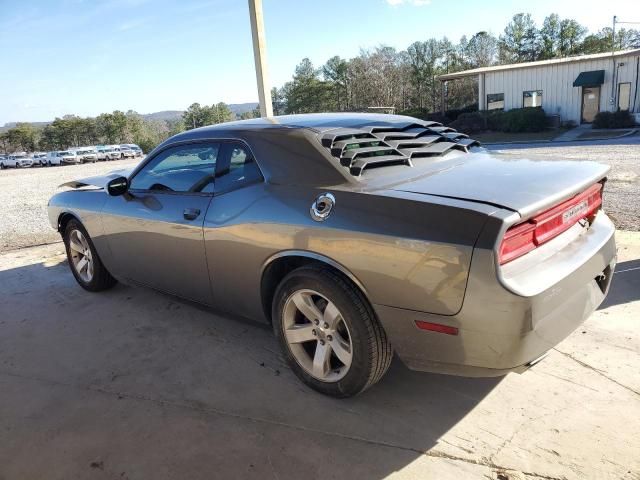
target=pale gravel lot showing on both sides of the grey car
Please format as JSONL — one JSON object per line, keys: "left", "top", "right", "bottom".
{"left": 0, "top": 136, "right": 640, "bottom": 251}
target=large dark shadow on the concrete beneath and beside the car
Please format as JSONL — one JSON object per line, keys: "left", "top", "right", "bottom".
{"left": 0, "top": 251, "right": 500, "bottom": 478}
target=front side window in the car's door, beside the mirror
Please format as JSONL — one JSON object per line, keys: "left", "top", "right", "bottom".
{"left": 131, "top": 143, "right": 220, "bottom": 193}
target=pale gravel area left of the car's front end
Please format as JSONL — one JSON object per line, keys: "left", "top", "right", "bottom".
{"left": 0, "top": 158, "right": 140, "bottom": 251}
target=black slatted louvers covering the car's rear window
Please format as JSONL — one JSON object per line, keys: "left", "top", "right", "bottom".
{"left": 320, "top": 121, "right": 480, "bottom": 177}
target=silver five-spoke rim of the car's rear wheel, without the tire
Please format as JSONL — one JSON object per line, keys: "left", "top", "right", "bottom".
{"left": 282, "top": 289, "right": 353, "bottom": 382}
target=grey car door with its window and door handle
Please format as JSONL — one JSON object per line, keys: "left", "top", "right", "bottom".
{"left": 103, "top": 142, "right": 219, "bottom": 303}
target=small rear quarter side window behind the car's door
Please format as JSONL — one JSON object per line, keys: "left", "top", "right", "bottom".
{"left": 216, "top": 143, "right": 262, "bottom": 192}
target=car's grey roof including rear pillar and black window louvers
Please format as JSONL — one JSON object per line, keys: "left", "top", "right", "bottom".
{"left": 158, "top": 113, "right": 478, "bottom": 186}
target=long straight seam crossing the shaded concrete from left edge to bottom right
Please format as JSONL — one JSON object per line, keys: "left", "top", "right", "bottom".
{"left": 0, "top": 371, "right": 566, "bottom": 480}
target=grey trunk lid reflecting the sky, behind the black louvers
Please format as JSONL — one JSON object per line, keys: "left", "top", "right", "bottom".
{"left": 392, "top": 153, "right": 610, "bottom": 218}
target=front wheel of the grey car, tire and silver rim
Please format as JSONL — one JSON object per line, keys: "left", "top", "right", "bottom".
{"left": 63, "top": 220, "right": 117, "bottom": 292}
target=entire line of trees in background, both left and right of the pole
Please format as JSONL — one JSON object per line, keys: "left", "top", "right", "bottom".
{"left": 0, "top": 13, "right": 640, "bottom": 152}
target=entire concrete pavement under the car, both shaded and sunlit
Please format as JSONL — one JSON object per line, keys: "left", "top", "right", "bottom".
{"left": 0, "top": 232, "right": 640, "bottom": 480}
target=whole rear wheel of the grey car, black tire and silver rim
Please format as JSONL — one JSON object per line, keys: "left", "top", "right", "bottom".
{"left": 272, "top": 265, "right": 393, "bottom": 398}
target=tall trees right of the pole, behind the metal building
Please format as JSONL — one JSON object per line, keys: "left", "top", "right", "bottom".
{"left": 272, "top": 13, "right": 640, "bottom": 115}
